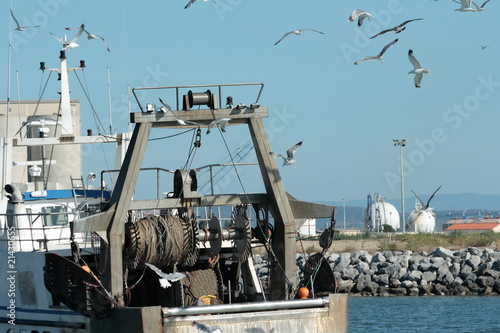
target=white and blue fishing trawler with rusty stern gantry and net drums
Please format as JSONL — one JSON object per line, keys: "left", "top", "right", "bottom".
{"left": 0, "top": 51, "right": 347, "bottom": 333}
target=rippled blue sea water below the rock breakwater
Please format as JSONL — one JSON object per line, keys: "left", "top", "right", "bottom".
{"left": 349, "top": 296, "right": 500, "bottom": 333}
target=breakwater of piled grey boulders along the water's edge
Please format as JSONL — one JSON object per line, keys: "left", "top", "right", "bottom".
{"left": 254, "top": 247, "right": 500, "bottom": 296}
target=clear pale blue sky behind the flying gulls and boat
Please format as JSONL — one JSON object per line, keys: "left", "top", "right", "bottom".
{"left": 0, "top": 0, "right": 500, "bottom": 204}
